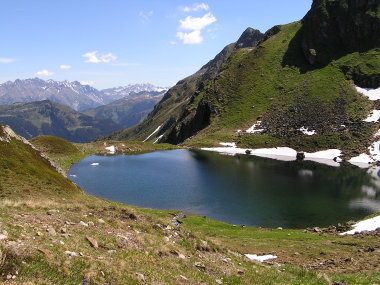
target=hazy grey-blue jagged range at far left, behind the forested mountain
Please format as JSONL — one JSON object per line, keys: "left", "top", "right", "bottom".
{"left": 0, "top": 78, "right": 104, "bottom": 111}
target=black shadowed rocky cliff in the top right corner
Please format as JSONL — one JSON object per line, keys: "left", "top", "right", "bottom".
{"left": 300, "top": 0, "right": 380, "bottom": 68}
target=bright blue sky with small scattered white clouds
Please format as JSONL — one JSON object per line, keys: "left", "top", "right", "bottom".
{"left": 0, "top": 0, "right": 312, "bottom": 89}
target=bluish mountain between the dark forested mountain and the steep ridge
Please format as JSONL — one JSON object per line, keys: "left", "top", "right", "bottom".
{"left": 83, "top": 88, "right": 165, "bottom": 128}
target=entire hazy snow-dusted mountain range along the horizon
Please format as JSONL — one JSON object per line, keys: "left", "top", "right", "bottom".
{"left": 0, "top": 78, "right": 166, "bottom": 111}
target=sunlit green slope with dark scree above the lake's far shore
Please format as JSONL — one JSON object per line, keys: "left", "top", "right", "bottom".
{"left": 186, "top": 22, "right": 380, "bottom": 159}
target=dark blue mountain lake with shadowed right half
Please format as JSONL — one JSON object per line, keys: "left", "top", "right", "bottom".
{"left": 68, "top": 150, "right": 380, "bottom": 228}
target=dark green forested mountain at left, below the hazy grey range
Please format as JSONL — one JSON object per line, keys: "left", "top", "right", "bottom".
{"left": 0, "top": 100, "right": 122, "bottom": 142}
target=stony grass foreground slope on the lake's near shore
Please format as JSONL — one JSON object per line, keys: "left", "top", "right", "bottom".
{"left": 0, "top": 130, "right": 380, "bottom": 284}
